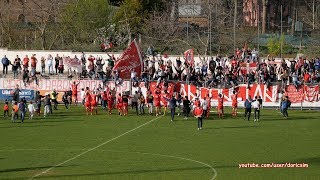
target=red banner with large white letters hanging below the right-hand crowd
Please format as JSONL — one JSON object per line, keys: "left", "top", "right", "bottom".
{"left": 133, "top": 82, "right": 319, "bottom": 105}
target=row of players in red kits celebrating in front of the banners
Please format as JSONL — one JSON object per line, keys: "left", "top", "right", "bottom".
{"left": 79, "top": 82, "right": 238, "bottom": 124}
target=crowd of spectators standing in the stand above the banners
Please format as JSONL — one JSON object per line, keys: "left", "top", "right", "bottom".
{"left": 2, "top": 47, "right": 320, "bottom": 88}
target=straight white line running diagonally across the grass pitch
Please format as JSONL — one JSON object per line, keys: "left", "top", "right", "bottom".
{"left": 30, "top": 116, "right": 163, "bottom": 179}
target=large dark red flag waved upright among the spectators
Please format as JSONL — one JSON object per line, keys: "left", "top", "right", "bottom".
{"left": 113, "top": 40, "right": 143, "bottom": 79}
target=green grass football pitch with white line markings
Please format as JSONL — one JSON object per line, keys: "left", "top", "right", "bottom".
{"left": 0, "top": 104, "right": 320, "bottom": 180}
